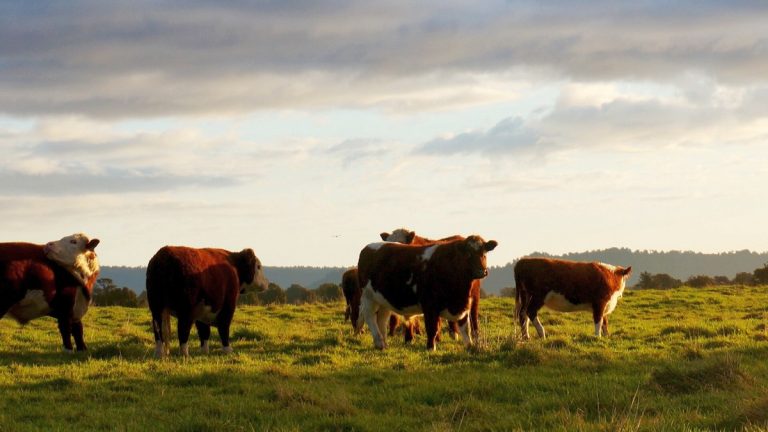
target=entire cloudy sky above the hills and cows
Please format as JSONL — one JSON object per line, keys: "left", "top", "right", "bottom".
{"left": 0, "top": 0, "right": 768, "bottom": 266}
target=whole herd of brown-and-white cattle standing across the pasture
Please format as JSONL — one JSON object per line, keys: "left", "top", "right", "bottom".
{"left": 0, "top": 229, "right": 632, "bottom": 357}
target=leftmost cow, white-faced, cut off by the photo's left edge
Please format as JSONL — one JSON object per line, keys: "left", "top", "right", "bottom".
{"left": 0, "top": 233, "right": 99, "bottom": 353}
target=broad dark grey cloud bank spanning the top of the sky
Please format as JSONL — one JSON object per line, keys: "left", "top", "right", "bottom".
{"left": 0, "top": 0, "right": 768, "bottom": 118}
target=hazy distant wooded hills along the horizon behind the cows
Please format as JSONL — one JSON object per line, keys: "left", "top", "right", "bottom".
{"left": 101, "top": 248, "right": 768, "bottom": 294}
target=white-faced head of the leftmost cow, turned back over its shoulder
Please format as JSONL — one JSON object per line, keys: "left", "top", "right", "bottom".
{"left": 43, "top": 233, "right": 99, "bottom": 288}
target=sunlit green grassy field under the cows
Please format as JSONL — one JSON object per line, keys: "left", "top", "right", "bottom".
{"left": 0, "top": 287, "right": 768, "bottom": 431}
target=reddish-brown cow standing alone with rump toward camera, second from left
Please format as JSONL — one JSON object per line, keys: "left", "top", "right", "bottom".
{"left": 147, "top": 246, "right": 269, "bottom": 357}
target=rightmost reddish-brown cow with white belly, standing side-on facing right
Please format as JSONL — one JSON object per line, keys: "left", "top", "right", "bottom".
{"left": 515, "top": 258, "right": 632, "bottom": 339}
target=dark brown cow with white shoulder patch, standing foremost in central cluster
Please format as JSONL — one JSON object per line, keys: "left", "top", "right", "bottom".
{"left": 357, "top": 235, "right": 498, "bottom": 350}
